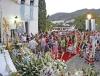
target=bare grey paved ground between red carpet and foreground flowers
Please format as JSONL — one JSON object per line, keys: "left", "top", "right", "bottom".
{"left": 67, "top": 55, "right": 100, "bottom": 71}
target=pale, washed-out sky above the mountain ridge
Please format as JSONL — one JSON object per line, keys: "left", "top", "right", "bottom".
{"left": 45, "top": 0, "right": 100, "bottom": 15}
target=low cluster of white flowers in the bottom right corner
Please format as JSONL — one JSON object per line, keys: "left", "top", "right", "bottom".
{"left": 66, "top": 64, "right": 100, "bottom": 76}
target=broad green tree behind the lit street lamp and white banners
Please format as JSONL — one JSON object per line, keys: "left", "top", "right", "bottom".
{"left": 74, "top": 12, "right": 100, "bottom": 31}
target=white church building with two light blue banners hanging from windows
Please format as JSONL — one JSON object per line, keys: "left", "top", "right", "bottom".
{"left": 0, "top": 0, "right": 39, "bottom": 41}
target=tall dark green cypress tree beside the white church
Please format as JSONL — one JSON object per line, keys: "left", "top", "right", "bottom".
{"left": 38, "top": 0, "right": 46, "bottom": 30}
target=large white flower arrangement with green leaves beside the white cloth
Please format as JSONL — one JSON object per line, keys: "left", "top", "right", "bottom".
{"left": 13, "top": 52, "right": 67, "bottom": 76}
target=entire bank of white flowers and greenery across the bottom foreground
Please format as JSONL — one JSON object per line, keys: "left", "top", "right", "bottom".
{"left": 12, "top": 47, "right": 98, "bottom": 76}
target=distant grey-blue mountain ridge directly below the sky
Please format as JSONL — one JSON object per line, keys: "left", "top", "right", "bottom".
{"left": 49, "top": 9, "right": 100, "bottom": 21}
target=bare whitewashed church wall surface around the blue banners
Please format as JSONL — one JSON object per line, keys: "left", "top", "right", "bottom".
{"left": 0, "top": 0, "right": 38, "bottom": 34}
